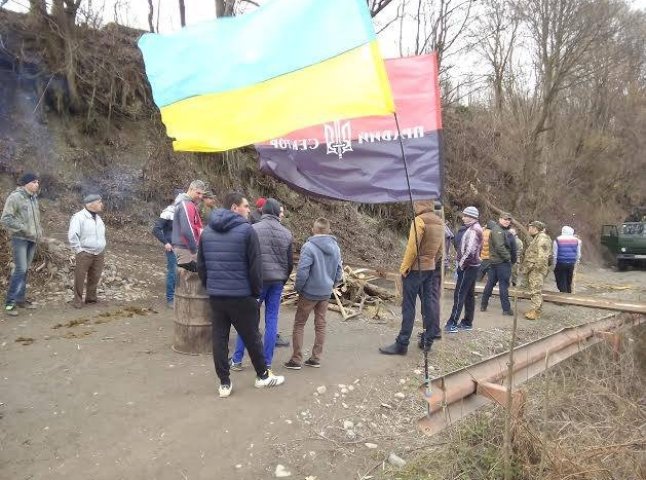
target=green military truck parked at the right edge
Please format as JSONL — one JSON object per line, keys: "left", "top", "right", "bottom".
{"left": 601, "top": 219, "right": 646, "bottom": 271}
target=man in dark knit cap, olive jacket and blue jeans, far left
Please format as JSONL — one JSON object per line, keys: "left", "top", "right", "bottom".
{"left": 0, "top": 173, "right": 43, "bottom": 316}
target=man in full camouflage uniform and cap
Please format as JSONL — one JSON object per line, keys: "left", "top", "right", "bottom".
{"left": 522, "top": 221, "right": 552, "bottom": 320}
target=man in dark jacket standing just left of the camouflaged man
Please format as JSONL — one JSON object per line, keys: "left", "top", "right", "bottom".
{"left": 480, "top": 213, "right": 516, "bottom": 316}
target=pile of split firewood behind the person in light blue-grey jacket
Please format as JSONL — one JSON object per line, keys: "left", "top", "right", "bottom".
{"left": 281, "top": 265, "right": 398, "bottom": 320}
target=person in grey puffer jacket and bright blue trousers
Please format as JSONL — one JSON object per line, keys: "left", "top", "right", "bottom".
{"left": 231, "top": 198, "right": 294, "bottom": 370}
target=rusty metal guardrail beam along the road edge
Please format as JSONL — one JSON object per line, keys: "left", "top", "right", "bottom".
{"left": 418, "top": 314, "right": 646, "bottom": 435}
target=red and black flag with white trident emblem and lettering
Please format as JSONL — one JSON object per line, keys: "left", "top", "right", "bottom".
{"left": 256, "top": 54, "right": 442, "bottom": 203}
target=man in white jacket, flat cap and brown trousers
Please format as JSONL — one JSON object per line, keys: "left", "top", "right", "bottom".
{"left": 67, "top": 193, "right": 106, "bottom": 308}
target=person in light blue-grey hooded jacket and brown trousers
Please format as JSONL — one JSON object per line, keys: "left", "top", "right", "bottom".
{"left": 284, "top": 217, "right": 343, "bottom": 370}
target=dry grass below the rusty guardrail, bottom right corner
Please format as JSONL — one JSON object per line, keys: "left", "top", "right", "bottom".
{"left": 390, "top": 326, "right": 646, "bottom": 480}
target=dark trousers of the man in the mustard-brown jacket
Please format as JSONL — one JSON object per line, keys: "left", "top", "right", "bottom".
{"left": 395, "top": 270, "right": 440, "bottom": 347}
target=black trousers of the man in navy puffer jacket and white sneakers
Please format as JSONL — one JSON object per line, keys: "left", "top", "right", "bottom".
{"left": 209, "top": 297, "right": 267, "bottom": 384}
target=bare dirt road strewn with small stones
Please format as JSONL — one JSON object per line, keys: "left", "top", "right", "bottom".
{"left": 0, "top": 264, "right": 646, "bottom": 480}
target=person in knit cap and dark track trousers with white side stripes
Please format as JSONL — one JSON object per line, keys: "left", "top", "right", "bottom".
{"left": 444, "top": 207, "right": 482, "bottom": 333}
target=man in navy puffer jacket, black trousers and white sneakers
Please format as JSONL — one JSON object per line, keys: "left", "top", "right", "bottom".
{"left": 197, "top": 192, "right": 285, "bottom": 398}
